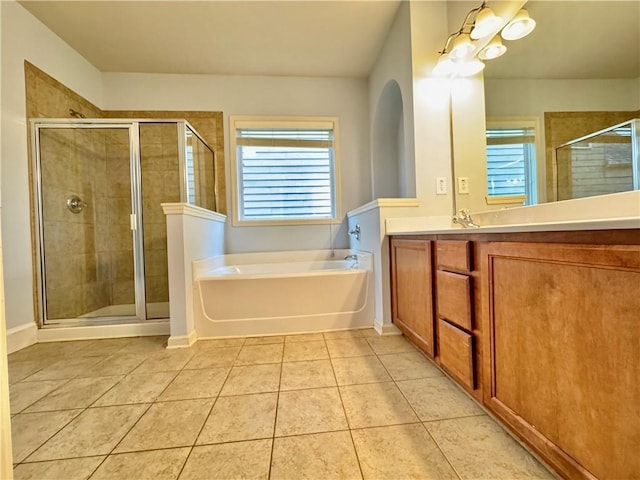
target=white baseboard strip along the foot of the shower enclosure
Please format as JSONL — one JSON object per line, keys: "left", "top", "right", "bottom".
{"left": 38, "top": 320, "right": 169, "bottom": 343}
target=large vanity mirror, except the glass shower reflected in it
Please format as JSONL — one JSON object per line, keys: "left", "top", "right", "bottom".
{"left": 452, "top": 0, "right": 640, "bottom": 211}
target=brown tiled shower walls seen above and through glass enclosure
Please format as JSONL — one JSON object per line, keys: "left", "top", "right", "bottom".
{"left": 25, "top": 62, "right": 226, "bottom": 318}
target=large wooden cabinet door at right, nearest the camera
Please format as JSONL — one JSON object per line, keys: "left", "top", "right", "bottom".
{"left": 481, "top": 242, "right": 640, "bottom": 479}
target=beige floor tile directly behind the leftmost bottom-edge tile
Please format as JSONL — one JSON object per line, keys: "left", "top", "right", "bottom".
{"left": 27, "top": 405, "right": 148, "bottom": 462}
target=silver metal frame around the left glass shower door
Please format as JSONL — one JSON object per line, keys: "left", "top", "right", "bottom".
{"left": 30, "top": 118, "right": 147, "bottom": 326}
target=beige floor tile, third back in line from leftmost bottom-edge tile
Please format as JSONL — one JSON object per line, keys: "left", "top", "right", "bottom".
{"left": 94, "top": 372, "right": 177, "bottom": 407}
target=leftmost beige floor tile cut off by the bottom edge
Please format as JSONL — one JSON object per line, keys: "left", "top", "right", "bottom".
{"left": 13, "top": 456, "right": 105, "bottom": 480}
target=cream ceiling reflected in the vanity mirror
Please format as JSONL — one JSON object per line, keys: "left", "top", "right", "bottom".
{"left": 484, "top": 0, "right": 640, "bottom": 79}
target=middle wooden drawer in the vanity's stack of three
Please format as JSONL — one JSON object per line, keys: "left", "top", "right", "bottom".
{"left": 436, "top": 270, "right": 473, "bottom": 330}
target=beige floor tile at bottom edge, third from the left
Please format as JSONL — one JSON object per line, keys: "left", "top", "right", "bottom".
{"left": 180, "top": 439, "right": 271, "bottom": 480}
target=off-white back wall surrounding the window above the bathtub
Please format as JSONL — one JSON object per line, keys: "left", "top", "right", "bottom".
{"left": 103, "top": 73, "right": 371, "bottom": 253}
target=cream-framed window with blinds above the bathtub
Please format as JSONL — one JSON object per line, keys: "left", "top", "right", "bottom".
{"left": 231, "top": 117, "right": 338, "bottom": 224}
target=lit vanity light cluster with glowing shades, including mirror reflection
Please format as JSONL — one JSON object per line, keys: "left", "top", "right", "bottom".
{"left": 433, "top": 1, "right": 536, "bottom": 77}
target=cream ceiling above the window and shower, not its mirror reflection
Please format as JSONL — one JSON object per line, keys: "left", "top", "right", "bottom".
{"left": 20, "top": 0, "right": 400, "bottom": 78}
